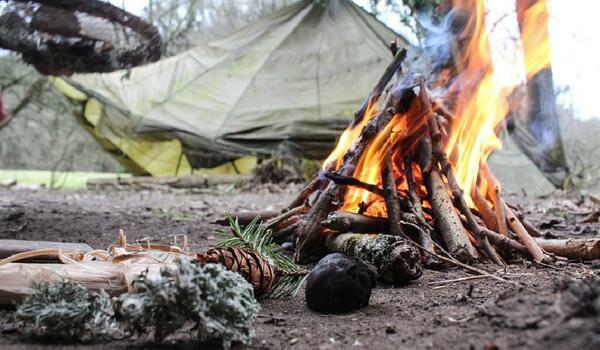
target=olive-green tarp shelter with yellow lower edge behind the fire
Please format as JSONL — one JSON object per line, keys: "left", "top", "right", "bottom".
{"left": 55, "top": 0, "right": 409, "bottom": 175}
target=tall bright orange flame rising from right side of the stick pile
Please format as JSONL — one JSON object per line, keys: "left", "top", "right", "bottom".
{"left": 446, "top": 0, "right": 512, "bottom": 200}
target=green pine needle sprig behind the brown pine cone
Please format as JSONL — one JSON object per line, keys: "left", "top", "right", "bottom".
{"left": 219, "top": 214, "right": 308, "bottom": 298}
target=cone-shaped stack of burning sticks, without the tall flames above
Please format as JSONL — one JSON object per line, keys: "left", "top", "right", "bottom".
{"left": 221, "top": 50, "right": 595, "bottom": 265}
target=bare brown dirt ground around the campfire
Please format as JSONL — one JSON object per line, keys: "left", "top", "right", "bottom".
{"left": 0, "top": 186, "right": 600, "bottom": 349}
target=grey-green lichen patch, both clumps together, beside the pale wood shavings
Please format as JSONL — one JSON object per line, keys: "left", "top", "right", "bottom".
{"left": 16, "top": 258, "right": 260, "bottom": 349}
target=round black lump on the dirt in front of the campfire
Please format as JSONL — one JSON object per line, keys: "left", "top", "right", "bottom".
{"left": 305, "top": 253, "right": 377, "bottom": 313}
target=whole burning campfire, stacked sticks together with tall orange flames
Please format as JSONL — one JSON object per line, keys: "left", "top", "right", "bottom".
{"left": 229, "top": 0, "right": 596, "bottom": 265}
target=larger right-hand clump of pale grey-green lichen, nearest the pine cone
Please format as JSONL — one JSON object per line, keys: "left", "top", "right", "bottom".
{"left": 119, "top": 259, "right": 260, "bottom": 348}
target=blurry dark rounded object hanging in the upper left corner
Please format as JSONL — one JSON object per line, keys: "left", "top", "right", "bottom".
{"left": 0, "top": 0, "right": 162, "bottom": 75}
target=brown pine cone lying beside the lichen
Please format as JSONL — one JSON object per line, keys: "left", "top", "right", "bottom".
{"left": 201, "top": 248, "right": 277, "bottom": 298}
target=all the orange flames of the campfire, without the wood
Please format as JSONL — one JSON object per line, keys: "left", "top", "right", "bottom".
{"left": 324, "top": 0, "right": 550, "bottom": 216}
